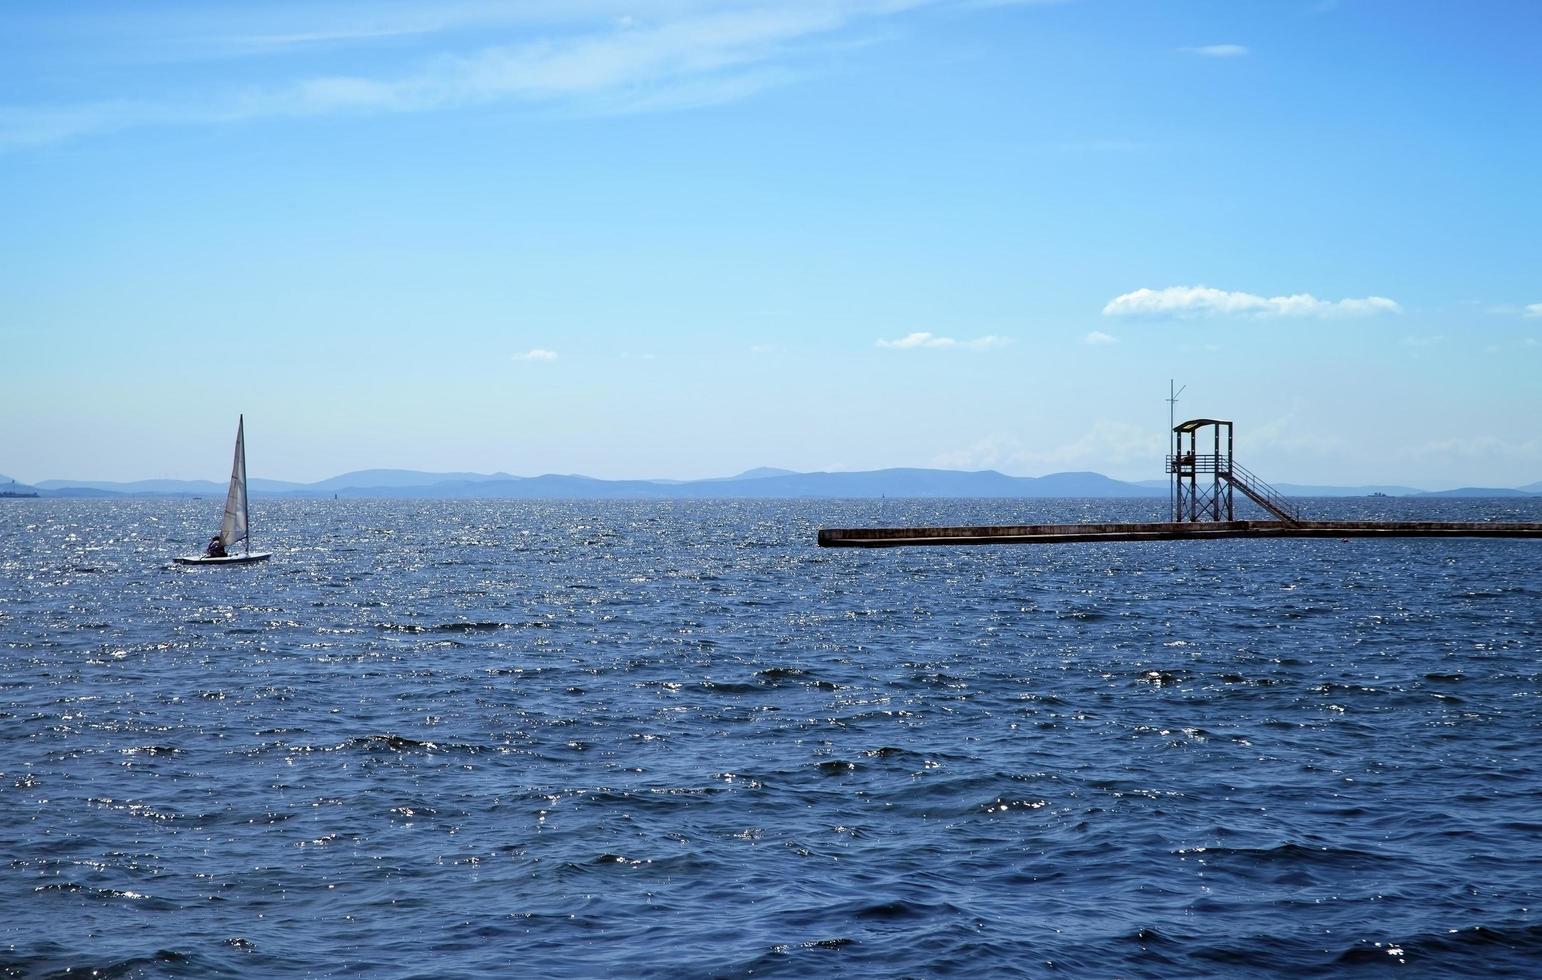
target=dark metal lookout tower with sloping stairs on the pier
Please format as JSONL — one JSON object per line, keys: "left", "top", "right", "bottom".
{"left": 1167, "top": 419, "right": 1301, "bottom": 524}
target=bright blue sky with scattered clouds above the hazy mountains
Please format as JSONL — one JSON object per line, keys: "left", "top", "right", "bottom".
{"left": 0, "top": 0, "right": 1542, "bottom": 488}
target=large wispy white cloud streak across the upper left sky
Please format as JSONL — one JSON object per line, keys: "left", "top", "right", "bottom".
{"left": 0, "top": 0, "right": 1036, "bottom": 149}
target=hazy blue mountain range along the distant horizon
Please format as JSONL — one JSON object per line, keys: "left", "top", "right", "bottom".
{"left": 0, "top": 467, "right": 1542, "bottom": 499}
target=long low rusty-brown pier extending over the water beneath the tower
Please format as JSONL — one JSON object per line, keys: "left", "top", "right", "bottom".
{"left": 819, "top": 521, "right": 1542, "bottom": 549}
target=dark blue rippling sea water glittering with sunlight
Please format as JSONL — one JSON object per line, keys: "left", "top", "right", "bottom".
{"left": 0, "top": 499, "right": 1542, "bottom": 977}
